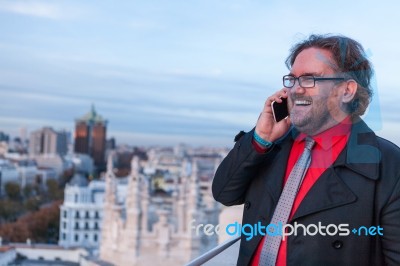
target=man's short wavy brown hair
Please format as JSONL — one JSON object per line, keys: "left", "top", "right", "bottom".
{"left": 285, "top": 34, "right": 373, "bottom": 116}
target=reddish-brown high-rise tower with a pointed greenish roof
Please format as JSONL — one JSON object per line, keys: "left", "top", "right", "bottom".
{"left": 74, "top": 106, "right": 107, "bottom": 169}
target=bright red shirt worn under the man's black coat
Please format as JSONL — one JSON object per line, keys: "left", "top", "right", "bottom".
{"left": 251, "top": 117, "right": 351, "bottom": 266}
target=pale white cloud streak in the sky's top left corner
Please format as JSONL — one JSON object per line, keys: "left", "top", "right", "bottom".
{"left": 0, "top": 1, "right": 76, "bottom": 20}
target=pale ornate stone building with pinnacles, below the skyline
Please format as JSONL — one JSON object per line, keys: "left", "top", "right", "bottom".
{"left": 100, "top": 153, "right": 219, "bottom": 266}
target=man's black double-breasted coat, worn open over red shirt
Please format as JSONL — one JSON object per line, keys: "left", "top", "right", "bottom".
{"left": 212, "top": 120, "right": 400, "bottom": 266}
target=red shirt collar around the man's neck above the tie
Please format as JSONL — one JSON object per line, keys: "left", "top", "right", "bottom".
{"left": 295, "top": 116, "right": 352, "bottom": 150}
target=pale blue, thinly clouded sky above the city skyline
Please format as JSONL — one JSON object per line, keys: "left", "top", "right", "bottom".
{"left": 0, "top": 0, "right": 400, "bottom": 147}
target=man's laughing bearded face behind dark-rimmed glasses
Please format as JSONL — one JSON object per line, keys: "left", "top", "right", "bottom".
{"left": 289, "top": 48, "right": 346, "bottom": 135}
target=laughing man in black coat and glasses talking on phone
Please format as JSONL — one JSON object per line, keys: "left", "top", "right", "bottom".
{"left": 213, "top": 35, "right": 400, "bottom": 266}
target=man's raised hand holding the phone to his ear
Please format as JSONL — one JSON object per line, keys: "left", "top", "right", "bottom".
{"left": 255, "top": 89, "right": 290, "bottom": 142}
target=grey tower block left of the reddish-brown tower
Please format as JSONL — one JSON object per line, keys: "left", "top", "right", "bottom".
{"left": 29, "top": 127, "right": 67, "bottom": 155}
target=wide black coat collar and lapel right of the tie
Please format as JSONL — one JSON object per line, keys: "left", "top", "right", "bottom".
{"left": 291, "top": 120, "right": 380, "bottom": 221}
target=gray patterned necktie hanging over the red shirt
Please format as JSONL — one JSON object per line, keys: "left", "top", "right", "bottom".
{"left": 258, "top": 137, "right": 315, "bottom": 266}
